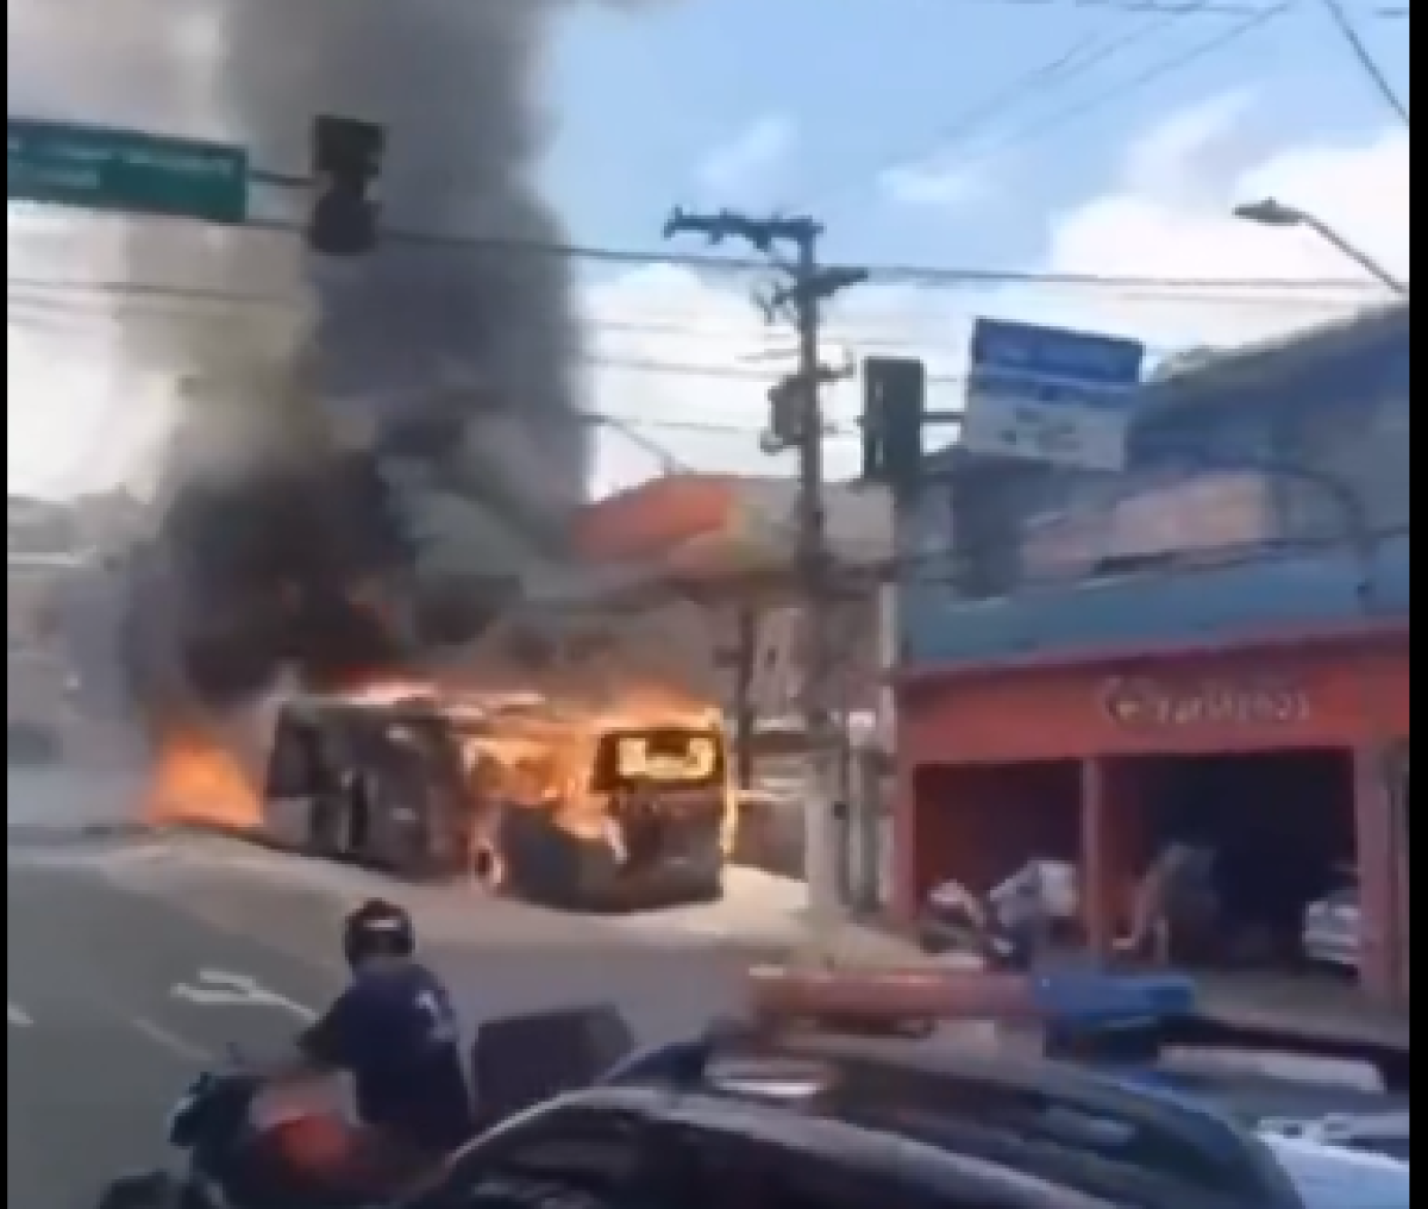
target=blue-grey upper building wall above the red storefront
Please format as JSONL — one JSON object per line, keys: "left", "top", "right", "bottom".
{"left": 898, "top": 308, "right": 1411, "bottom": 668}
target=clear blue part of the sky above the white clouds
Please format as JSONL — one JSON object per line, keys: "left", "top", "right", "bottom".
{"left": 548, "top": 0, "right": 1409, "bottom": 265}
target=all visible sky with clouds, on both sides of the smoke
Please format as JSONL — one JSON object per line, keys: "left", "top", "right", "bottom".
{"left": 7, "top": 0, "right": 1411, "bottom": 494}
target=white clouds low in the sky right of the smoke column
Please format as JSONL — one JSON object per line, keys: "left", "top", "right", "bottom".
{"left": 579, "top": 93, "right": 1411, "bottom": 487}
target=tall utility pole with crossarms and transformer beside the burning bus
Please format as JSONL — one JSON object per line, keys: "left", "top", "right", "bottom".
{"left": 664, "top": 210, "right": 867, "bottom": 963}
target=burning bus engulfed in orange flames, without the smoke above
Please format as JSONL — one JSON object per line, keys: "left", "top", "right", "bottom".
{"left": 258, "top": 689, "right": 738, "bottom": 911}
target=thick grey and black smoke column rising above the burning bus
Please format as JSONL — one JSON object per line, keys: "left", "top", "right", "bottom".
{"left": 7, "top": 0, "right": 668, "bottom": 713}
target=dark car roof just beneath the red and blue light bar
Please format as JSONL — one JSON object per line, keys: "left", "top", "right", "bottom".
{"left": 582, "top": 1033, "right": 1294, "bottom": 1209}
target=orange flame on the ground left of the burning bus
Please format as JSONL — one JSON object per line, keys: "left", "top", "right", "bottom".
{"left": 144, "top": 728, "right": 263, "bottom": 831}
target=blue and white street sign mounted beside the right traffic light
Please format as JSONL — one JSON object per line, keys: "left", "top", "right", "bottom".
{"left": 961, "top": 318, "right": 1145, "bottom": 470}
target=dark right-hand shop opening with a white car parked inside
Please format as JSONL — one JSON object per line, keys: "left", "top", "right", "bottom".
{"left": 1127, "top": 749, "right": 1361, "bottom": 973}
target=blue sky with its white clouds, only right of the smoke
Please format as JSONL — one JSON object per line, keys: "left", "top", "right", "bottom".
{"left": 545, "top": 0, "right": 1409, "bottom": 487}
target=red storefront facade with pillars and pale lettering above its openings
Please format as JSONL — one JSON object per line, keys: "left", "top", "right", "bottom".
{"left": 895, "top": 625, "right": 1411, "bottom": 998}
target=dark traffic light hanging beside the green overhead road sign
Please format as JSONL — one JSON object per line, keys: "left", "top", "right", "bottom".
{"left": 307, "top": 117, "right": 386, "bottom": 257}
